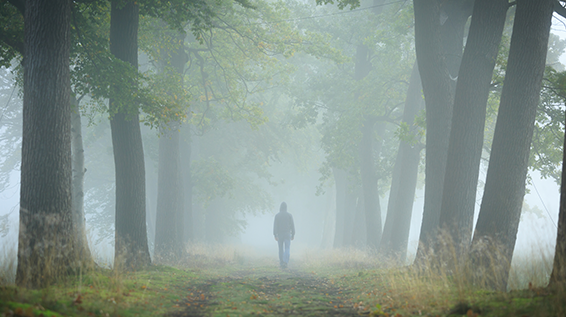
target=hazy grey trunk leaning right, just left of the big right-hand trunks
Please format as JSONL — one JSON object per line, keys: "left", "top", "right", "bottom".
{"left": 380, "top": 63, "right": 424, "bottom": 264}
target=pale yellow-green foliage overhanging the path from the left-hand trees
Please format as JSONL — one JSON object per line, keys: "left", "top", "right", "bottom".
{"left": 181, "top": 1, "right": 302, "bottom": 129}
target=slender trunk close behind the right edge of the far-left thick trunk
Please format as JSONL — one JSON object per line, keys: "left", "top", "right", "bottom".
{"left": 70, "top": 95, "right": 94, "bottom": 266}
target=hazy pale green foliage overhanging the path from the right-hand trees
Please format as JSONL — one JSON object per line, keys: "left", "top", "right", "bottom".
{"left": 292, "top": 0, "right": 415, "bottom": 190}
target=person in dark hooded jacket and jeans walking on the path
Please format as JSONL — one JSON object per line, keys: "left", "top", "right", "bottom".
{"left": 273, "top": 202, "right": 295, "bottom": 269}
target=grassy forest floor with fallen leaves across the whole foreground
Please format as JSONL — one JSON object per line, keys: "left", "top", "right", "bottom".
{"left": 0, "top": 244, "right": 566, "bottom": 317}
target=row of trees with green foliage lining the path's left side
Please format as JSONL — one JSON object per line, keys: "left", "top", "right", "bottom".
{"left": 2, "top": 1, "right": 330, "bottom": 287}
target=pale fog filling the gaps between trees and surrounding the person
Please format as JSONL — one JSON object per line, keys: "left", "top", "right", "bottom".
{"left": 0, "top": 1, "right": 566, "bottom": 276}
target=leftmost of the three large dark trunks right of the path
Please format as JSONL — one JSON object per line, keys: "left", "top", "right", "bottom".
{"left": 414, "top": 0, "right": 469, "bottom": 259}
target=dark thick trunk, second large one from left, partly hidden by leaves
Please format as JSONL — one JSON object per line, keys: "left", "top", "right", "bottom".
{"left": 110, "top": 1, "right": 151, "bottom": 269}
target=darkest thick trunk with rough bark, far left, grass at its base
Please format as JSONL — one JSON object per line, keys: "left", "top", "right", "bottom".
{"left": 16, "top": 0, "right": 77, "bottom": 288}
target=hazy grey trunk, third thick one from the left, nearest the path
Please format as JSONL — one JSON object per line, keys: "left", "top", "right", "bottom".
{"left": 155, "top": 33, "right": 187, "bottom": 260}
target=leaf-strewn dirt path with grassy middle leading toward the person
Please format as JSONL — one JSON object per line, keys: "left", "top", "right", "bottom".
{"left": 170, "top": 268, "right": 360, "bottom": 317}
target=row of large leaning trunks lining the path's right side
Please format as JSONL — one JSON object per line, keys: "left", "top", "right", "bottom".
{"left": 310, "top": 0, "right": 563, "bottom": 288}
